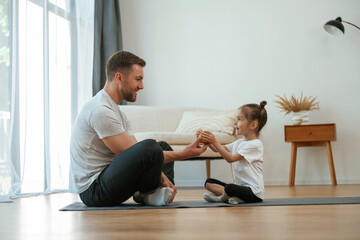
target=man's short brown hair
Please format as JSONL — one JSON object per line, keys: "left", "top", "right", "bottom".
{"left": 105, "top": 51, "right": 146, "bottom": 80}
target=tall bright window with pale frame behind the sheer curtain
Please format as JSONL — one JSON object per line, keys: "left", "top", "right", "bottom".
{"left": 12, "top": 0, "right": 75, "bottom": 194}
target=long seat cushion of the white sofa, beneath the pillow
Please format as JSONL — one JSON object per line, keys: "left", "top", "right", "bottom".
{"left": 135, "top": 132, "right": 236, "bottom": 145}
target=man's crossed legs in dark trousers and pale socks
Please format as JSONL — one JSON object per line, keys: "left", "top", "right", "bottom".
{"left": 80, "top": 139, "right": 174, "bottom": 207}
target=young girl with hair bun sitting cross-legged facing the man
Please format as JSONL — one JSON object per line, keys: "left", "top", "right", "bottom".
{"left": 197, "top": 101, "right": 267, "bottom": 204}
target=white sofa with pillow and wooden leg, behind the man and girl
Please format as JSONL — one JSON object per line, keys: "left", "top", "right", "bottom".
{"left": 119, "top": 105, "right": 237, "bottom": 177}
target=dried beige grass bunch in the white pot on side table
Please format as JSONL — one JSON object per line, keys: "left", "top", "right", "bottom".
{"left": 275, "top": 92, "right": 319, "bottom": 115}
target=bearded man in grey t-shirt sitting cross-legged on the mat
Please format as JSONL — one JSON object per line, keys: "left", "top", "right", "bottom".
{"left": 69, "top": 51, "right": 208, "bottom": 206}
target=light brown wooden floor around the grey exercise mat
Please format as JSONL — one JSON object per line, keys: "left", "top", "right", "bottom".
{"left": 0, "top": 185, "right": 360, "bottom": 240}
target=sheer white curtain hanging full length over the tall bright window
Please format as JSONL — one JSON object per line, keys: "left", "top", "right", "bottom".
{"left": 0, "top": 0, "right": 94, "bottom": 200}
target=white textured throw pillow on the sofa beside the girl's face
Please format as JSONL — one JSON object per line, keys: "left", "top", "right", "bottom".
{"left": 175, "top": 110, "right": 236, "bottom": 134}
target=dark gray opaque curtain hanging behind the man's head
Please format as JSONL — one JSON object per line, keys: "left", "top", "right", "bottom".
{"left": 93, "top": 0, "right": 126, "bottom": 104}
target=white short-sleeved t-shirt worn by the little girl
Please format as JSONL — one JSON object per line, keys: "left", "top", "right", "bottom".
{"left": 225, "top": 139, "right": 265, "bottom": 199}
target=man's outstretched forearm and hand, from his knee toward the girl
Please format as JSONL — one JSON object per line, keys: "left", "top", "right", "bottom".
{"left": 164, "top": 138, "right": 209, "bottom": 163}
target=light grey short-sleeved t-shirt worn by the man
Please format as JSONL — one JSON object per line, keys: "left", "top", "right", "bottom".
{"left": 69, "top": 89, "right": 133, "bottom": 193}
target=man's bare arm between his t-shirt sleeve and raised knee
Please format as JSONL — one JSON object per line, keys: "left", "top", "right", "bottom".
{"left": 102, "top": 132, "right": 137, "bottom": 155}
